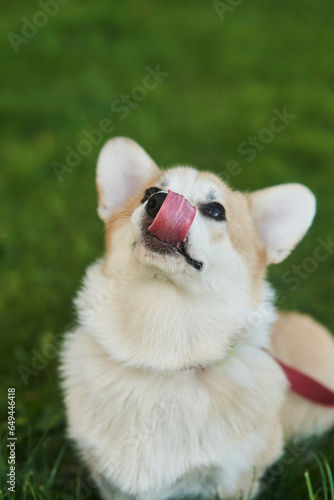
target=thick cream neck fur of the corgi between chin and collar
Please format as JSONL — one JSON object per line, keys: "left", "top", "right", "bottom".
{"left": 76, "top": 262, "right": 276, "bottom": 370}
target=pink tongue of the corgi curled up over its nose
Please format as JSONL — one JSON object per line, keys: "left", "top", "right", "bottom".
{"left": 148, "top": 191, "right": 196, "bottom": 243}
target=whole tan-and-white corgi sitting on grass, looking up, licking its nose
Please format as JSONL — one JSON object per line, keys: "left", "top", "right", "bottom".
{"left": 61, "top": 137, "right": 334, "bottom": 500}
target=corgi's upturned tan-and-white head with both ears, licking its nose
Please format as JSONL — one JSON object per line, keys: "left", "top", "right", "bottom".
{"left": 97, "top": 137, "right": 315, "bottom": 289}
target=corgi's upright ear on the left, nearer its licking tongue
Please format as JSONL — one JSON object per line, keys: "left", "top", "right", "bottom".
{"left": 96, "top": 137, "right": 159, "bottom": 222}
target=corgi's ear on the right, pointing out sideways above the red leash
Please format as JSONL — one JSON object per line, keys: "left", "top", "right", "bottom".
{"left": 247, "top": 184, "right": 316, "bottom": 264}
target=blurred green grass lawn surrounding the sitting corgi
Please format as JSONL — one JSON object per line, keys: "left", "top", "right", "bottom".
{"left": 0, "top": 0, "right": 334, "bottom": 500}
